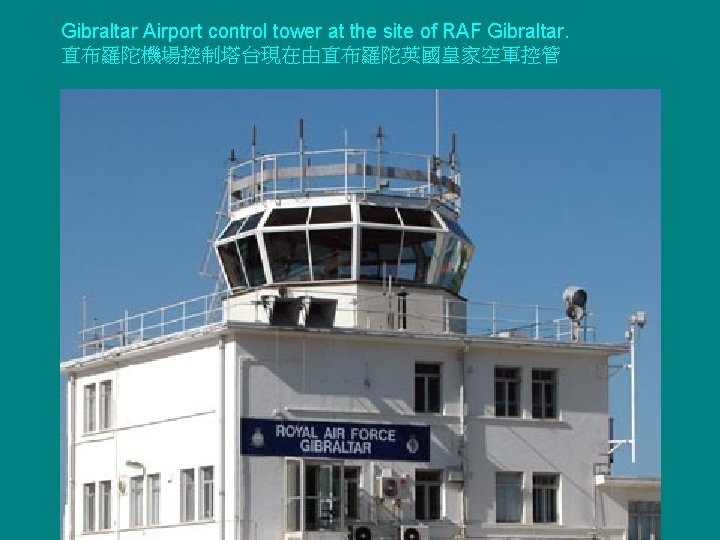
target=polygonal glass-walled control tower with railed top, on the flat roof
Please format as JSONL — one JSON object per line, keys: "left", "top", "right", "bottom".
{"left": 214, "top": 120, "right": 473, "bottom": 333}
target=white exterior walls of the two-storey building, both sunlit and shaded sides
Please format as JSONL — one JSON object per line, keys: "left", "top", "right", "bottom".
{"left": 66, "top": 330, "right": 622, "bottom": 540}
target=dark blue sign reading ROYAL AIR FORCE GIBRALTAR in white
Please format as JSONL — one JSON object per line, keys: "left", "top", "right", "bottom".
{"left": 240, "top": 418, "right": 430, "bottom": 461}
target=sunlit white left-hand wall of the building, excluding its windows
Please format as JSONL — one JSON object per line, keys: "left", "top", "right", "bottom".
{"left": 75, "top": 342, "right": 219, "bottom": 538}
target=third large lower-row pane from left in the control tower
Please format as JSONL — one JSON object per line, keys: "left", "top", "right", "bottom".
{"left": 265, "top": 231, "right": 310, "bottom": 283}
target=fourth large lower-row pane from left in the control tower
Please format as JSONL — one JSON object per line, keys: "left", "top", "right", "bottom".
{"left": 310, "top": 229, "right": 352, "bottom": 280}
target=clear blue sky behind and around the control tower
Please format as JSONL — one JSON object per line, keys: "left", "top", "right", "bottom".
{"left": 60, "top": 90, "right": 661, "bottom": 476}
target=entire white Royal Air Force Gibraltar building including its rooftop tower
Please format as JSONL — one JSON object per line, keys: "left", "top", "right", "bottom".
{"left": 62, "top": 140, "right": 660, "bottom": 540}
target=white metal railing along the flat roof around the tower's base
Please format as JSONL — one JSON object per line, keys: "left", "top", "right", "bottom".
{"left": 79, "top": 289, "right": 596, "bottom": 356}
